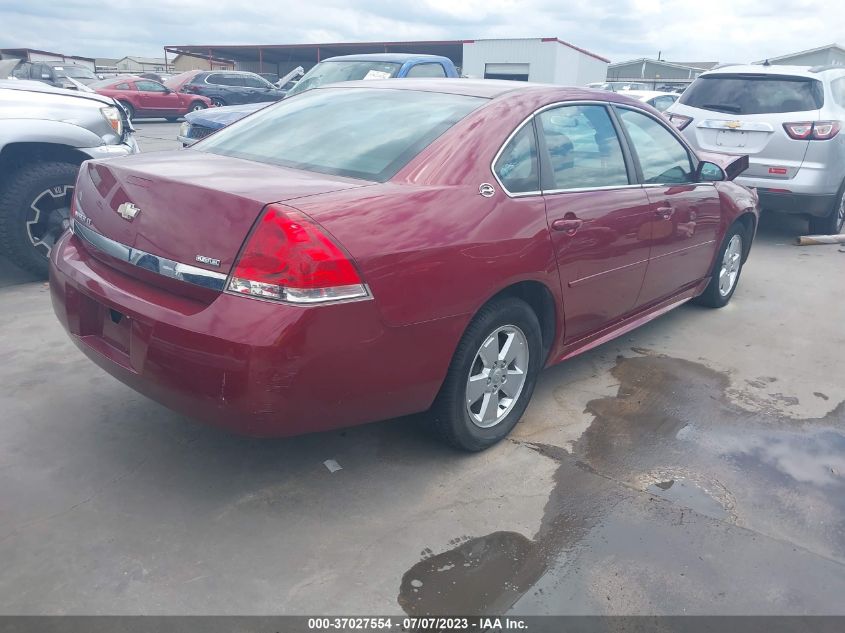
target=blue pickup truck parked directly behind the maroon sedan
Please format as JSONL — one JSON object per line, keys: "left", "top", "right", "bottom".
{"left": 177, "top": 53, "right": 458, "bottom": 146}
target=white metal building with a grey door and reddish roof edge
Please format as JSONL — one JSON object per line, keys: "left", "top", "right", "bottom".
{"left": 462, "top": 37, "right": 610, "bottom": 86}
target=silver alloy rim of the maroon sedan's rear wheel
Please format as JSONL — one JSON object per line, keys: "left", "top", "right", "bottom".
{"left": 466, "top": 325, "right": 529, "bottom": 429}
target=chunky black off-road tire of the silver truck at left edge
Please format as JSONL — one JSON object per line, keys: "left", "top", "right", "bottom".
{"left": 0, "top": 162, "right": 79, "bottom": 278}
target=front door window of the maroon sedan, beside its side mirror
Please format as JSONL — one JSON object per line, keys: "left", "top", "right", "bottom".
{"left": 617, "top": 108, "right": 693, "bottom": 184}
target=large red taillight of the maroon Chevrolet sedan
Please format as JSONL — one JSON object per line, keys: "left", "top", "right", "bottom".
{"left": 228, "top": 205, "right": 369, "bottom": 303}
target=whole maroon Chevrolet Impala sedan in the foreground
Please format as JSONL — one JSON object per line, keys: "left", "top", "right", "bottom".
{"left": 50, "top": 79, "right": 758, "bottom": 450}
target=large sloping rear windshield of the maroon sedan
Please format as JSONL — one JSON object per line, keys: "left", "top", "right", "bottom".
{"left": 198, "top": 88, "right": 487, "bottom": 182}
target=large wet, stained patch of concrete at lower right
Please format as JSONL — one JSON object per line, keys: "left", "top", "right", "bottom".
{"left": 399, "top": 355, "right": 845, "bottom": 615}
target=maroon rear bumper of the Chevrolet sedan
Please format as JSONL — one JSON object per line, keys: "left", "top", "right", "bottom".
{"left": 50, "top": 233, "right": 464, "bottom": 436}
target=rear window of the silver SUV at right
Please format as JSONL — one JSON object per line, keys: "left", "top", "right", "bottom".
{"left": 680, "top": 75, "right": 824, "bottom": 114}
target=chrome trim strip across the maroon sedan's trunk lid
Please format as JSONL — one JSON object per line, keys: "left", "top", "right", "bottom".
{"left": 71, "top": 221, "right": 228, "bottom": 292}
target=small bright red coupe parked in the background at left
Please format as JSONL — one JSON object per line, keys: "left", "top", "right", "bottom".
{"left": 90, "top": 76, "right": 212, "bottom": 121}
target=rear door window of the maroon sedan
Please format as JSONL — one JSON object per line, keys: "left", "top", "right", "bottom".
{"left": 538, "top": 105, "right": 629, "bottom": 189}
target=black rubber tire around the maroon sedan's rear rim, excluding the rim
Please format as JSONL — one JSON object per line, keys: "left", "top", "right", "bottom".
{"left": 431, "top": 297, "right": 545, "bottom": 451}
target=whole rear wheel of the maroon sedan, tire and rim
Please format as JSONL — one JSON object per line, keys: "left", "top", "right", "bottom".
{"left": 432, "top": 297, "right": 544, "bottom": 451}
